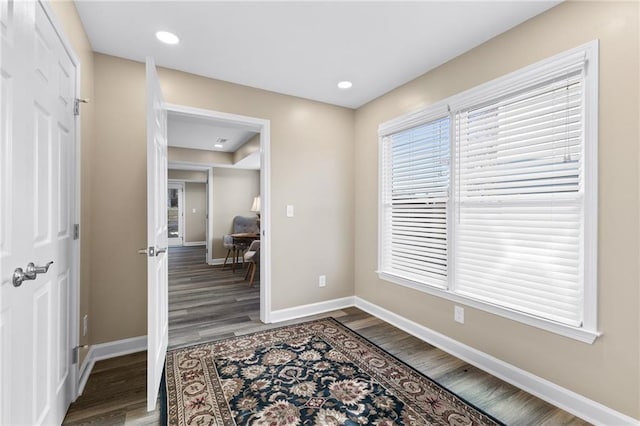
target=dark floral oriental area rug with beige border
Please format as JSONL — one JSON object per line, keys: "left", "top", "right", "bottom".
{"left": 166, "top": 318, "right": 501, "bottom": 426}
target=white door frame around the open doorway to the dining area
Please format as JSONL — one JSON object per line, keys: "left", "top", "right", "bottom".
{"left": 164, "top": 102, "right": 271, "bottom": 323}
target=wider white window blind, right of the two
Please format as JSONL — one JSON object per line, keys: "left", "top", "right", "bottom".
{"left": 455, "top": 69, "right": 584, "bottom": 326}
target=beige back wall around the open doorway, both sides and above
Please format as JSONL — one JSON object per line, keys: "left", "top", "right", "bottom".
{"left": 91, "top": 53, "right": 354, "bottom": 343}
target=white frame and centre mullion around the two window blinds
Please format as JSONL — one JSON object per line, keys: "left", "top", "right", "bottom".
{"left": 376, "top": 40, "right": 601, "bottom": 344}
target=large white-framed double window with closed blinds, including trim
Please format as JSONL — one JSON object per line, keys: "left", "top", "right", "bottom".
{"left": 378, "top": 42, "right": 598, "bottom": 342}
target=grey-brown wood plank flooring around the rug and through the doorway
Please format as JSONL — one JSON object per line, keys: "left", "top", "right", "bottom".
{"left": 64, "top": 247, "right": 588, "bottom": 426}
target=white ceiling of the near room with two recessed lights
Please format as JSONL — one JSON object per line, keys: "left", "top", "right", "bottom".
{"left": 76, "top": 0, "right": 560, "bottom": 108}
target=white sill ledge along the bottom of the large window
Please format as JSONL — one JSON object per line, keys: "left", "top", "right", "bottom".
{"left": 377, "top": 271, "right": 601, "bottom": 344}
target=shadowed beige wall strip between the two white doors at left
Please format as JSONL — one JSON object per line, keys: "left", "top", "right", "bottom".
{"left": 90, "top": 54, "right": 147, "bottom": 344}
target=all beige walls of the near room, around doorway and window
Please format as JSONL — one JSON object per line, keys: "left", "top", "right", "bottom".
{"left": 53, "top": 2, "right": 640, "bottom": 418}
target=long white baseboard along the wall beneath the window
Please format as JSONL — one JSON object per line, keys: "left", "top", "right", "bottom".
{"left": 354, "top": 296, "right": 640, "bottom": 426}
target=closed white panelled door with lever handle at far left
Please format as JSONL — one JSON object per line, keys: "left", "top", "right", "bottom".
{"left": 0, "top": 0, "right": 77, "bottom": 425}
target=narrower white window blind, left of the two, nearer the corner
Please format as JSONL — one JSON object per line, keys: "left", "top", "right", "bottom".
{"left": 381, "top": 116, "right": 450, "bottom": 288}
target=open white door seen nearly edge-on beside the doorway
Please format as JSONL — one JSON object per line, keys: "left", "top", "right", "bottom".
{"left": 147, "top": 58, "right": 169, "bottom": 411}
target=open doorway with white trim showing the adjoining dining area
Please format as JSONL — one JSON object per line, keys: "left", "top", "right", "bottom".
{"left": 166, "top": 105, "right": 270, "bottom": 348}
